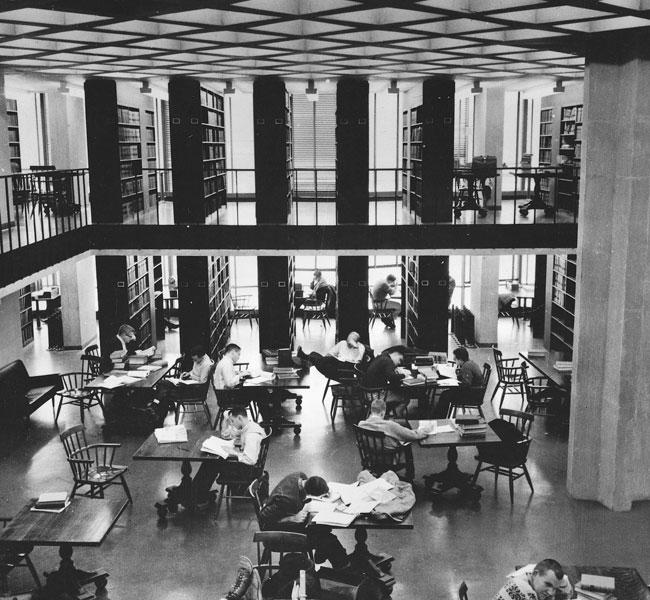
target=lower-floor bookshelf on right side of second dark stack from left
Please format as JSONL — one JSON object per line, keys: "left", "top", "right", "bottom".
{"left": 208, "top": 256, "right": 232, "bottom": 357}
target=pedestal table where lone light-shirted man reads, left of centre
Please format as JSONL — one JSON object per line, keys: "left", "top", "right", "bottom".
{"left": 133, "top": 427, "right": 223, "bottom": 520}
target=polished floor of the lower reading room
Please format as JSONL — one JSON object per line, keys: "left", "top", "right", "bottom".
{"left": 0, "top": 319, "right": 650, "bottom": 600}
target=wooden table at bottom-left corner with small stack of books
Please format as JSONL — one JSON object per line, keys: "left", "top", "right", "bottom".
{"left": 0, "top": 496, "right": 127, "bottom": 600}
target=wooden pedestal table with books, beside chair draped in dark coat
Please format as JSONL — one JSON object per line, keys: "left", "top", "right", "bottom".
{"left": 409, "top": 419, "right": 501, "bottom": 501}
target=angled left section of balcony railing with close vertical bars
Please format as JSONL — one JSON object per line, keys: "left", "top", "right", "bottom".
{"left": 0, "top": 169, "right": 91, "bottom": 254}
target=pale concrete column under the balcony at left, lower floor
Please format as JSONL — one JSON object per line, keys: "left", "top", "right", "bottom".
{"left": 59, "top": 256, "right": 97, "bottom": 349}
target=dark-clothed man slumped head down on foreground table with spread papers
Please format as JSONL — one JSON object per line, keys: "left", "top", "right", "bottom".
{"left": 260, "top": 472, "right": 348, "bottom": 569}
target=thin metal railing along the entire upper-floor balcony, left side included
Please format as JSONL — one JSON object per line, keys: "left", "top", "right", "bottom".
{"left": 0, "top": 167, "right": 578, "bottom": 253}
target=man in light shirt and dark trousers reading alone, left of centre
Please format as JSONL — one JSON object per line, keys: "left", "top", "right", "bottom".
{"left": 192, "top": 406, "right": 266, "bottom": 504}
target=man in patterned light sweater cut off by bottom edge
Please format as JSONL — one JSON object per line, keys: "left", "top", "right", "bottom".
{"left": 493, "top": 558, "right": 573, "bottom": 600}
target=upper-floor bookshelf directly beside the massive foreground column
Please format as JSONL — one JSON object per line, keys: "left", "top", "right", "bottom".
{"left": 557, "top": 104, "right": 583, "bottom": 212}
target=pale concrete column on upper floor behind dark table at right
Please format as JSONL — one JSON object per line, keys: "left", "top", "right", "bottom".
{"left": 474, "top": 87, "right": 505, "bottom": 207}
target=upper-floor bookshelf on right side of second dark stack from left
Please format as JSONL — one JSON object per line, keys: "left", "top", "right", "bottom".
{"left": 201, "top": 88, "right": 226, "bottom": 218}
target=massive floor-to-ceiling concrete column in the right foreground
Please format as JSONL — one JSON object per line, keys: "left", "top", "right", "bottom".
{"left": 567, "top": 41, "right": 650, "bottom": 510}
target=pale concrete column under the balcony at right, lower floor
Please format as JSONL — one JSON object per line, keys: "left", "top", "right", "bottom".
{"left": 470, "top": 255, "right": 499, "bottom": 346}
